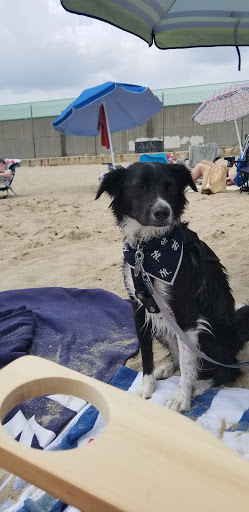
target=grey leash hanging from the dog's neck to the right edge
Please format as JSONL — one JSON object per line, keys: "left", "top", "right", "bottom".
{"left": 134, "top": 245, "right": 249, "bottom": 368}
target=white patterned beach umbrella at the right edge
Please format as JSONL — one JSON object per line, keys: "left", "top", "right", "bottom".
{"left": 192, "top": 82, "right": 249, "bottom": 153}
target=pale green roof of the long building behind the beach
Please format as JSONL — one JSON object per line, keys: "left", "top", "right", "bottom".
{"left": 0, "top": 81, "right": 248, "bottom": 121}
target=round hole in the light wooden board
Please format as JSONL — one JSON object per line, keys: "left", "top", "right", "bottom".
{"left": 1, "top": 378, "right": 106, "bottom": 450}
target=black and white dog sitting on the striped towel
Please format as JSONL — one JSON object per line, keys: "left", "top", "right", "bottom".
{"left": 96, "top": 162, "right": 249, "bottom": 411}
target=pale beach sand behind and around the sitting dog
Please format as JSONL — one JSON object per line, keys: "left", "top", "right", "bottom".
{"left": 0, "top": 164, "right": 249, "bottom": 380}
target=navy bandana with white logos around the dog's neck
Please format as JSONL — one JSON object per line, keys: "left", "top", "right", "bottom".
{"left": 123, "top": 227, "right": 183, "bottom": 284}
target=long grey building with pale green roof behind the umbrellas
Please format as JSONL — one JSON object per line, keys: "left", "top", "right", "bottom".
{"left": 0, "top": 82, "right": 249, "bottom": 158}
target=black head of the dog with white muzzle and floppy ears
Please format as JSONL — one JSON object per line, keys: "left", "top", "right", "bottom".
{"left": 96, "top": 162, "right": 197, "bottom": 239}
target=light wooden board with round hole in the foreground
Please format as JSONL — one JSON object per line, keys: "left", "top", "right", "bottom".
{"left": 0, "top": 356, "right": 249, "bottom": 512}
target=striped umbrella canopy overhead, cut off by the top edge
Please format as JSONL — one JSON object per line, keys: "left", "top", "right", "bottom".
{"left": 61, "top": 0, "right": 249, "bottom": 49}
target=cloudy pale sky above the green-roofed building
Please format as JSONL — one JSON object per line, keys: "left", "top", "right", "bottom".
{"left": 0, "top": 0, "right": 249, "bottom": 105}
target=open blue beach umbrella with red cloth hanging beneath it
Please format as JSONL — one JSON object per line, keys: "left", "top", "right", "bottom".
{"left": 52, "top": 82, "right": 163, "bottom": 167}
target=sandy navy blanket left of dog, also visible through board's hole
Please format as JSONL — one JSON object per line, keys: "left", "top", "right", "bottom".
{"left": 0, "top": 288, "right": 138, "bottom": 448}
